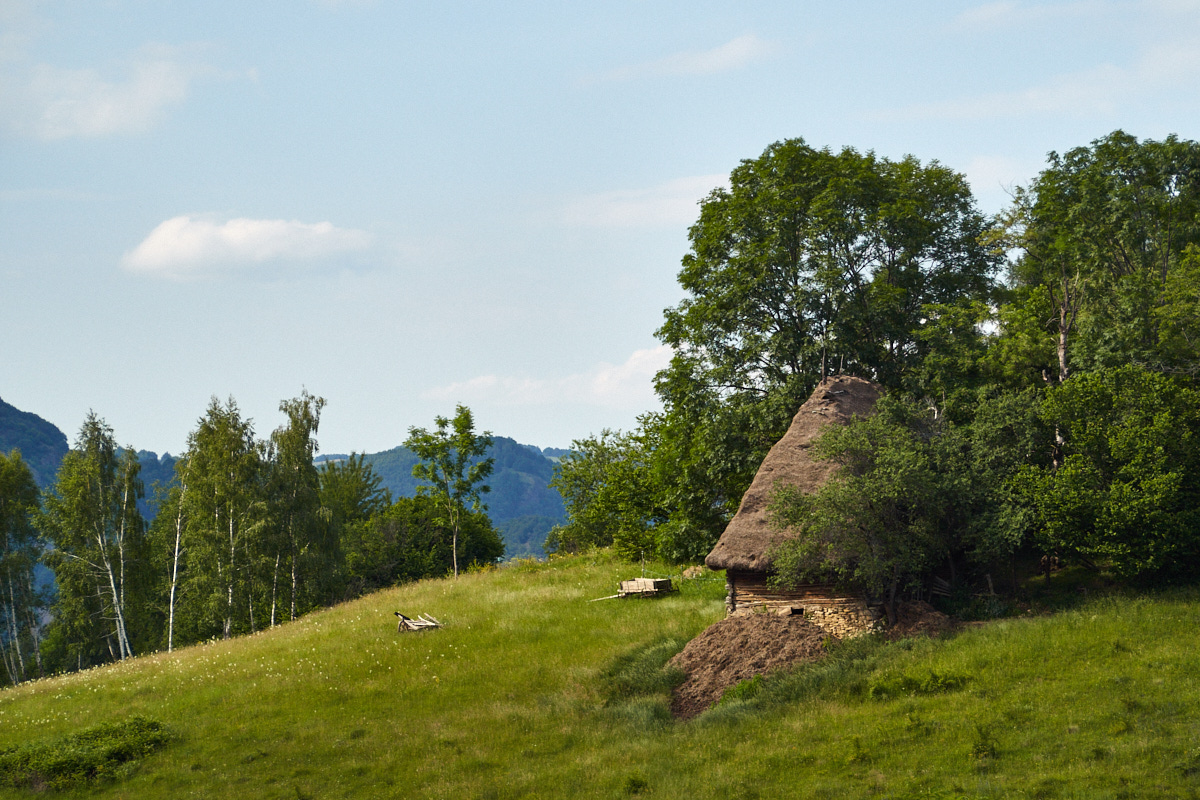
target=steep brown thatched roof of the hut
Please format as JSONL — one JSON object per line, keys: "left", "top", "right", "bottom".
{"left": 704, "top": 375, "right": 880, "bottom": 572}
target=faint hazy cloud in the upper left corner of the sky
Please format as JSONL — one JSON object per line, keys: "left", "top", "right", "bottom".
{"left": 0, "top": 46, "right": 216, "bottom": 142}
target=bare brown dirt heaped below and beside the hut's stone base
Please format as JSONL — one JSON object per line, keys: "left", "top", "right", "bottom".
{"left": 671, "top": 600, "right": 956, "bottom": 720}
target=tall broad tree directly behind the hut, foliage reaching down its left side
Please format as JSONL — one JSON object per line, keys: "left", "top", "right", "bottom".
{"left": 656, "top": 139, "right": 1001, "bottom": 553}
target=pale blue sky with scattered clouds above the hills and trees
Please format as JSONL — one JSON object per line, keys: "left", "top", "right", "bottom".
{"left": 0, "top": 0, "right": 1200, "bottom": 453}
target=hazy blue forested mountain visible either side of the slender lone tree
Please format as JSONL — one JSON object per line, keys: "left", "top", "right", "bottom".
{"left": 317, "top": 437, "right": 570, "bottom": 558}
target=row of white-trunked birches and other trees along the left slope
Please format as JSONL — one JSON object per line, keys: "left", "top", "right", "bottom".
{"left": 0, "top": 391, "right": 504, "bottom": 684}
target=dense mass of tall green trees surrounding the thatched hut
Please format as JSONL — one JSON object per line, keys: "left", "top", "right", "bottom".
{"left": 547, "top": 131, "right": 1200, "bottom": 599}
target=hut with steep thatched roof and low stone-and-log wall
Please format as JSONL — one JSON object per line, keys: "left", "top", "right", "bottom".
{"left": 704, "top": 375, "right": 882, "bottom": 637}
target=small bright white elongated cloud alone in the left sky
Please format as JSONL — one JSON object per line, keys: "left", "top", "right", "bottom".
{"left": 121, "top": 215, "right": 371, "bottom": 277}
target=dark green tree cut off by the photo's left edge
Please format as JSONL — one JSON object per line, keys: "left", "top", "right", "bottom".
{"left": 0, "top": 450, "right": 42, "bottom": 685}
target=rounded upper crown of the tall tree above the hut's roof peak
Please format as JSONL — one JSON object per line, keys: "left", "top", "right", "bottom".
{"left": 659, "top": 139, "right": 997, "bottom": 395}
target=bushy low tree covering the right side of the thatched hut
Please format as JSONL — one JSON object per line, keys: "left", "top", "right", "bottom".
{"left": 772, "top": 391, "right": 1049, "bottom": 619}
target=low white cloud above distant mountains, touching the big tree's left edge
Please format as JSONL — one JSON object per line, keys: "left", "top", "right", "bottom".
{"left": 424, "top": 344, "right": 672, "bottom": 411}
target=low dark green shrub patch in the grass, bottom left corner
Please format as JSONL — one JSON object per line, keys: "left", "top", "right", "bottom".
{"left": 0, "top": 716, "right": 172, "bottom": 792}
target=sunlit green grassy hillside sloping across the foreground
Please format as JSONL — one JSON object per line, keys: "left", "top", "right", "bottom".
{"left": 7, "top": 555, "right": 1200, "bottom": 800}
